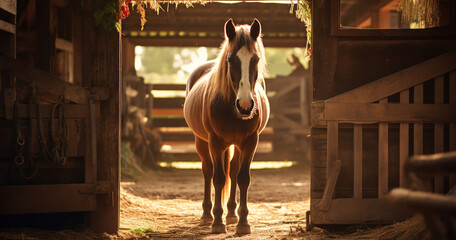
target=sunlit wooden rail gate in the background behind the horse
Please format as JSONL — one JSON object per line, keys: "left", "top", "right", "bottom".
{"left": 151, "top": 76, "right": 309, "bottom": 161}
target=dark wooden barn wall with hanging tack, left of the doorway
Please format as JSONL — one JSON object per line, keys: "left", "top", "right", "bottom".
{"left": 0, "top": 0, "right": 121, "bottom": 233}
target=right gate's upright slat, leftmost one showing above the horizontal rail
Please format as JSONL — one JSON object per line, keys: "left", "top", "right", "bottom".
{"left": 378, "top": 98, "right": 388, "bottom": 198}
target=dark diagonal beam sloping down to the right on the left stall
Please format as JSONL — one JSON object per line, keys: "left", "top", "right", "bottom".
{"left": 0, "top": 55, "right": 90, "bottom": 104}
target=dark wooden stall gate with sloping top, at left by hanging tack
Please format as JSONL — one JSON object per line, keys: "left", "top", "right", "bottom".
{"left": 0, "top": 56, "right": 110, "bottom": 214}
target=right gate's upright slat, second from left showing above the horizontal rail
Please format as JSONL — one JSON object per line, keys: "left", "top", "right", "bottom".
{"left": 399, "top": 89, "right": 410, "bottom": 187}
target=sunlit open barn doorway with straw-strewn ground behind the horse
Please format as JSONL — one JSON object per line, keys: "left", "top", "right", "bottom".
{"left": 121, "top": 2, "right": 310, "bottom": 238}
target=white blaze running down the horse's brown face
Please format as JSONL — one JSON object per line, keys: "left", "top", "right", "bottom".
{"left": 236, "top": 46, "right": 253, "bottom": 110}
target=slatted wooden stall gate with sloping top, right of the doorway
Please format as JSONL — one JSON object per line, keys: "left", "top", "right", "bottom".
{"left": 308, "top": 51, "right": 456, "bottom": 225}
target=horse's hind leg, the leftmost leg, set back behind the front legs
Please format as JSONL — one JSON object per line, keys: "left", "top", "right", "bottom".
{"left": 195, "top": 136, "right": 214, "bottom": 225}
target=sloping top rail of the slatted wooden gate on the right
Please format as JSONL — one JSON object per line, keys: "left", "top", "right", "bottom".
{"left": 326, "top": 51, "right": 456, "bottom": 103}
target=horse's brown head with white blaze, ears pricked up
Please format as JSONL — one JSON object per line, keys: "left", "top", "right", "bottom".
{"left": 225, "top": 19, "right": 265, "bottom": 119}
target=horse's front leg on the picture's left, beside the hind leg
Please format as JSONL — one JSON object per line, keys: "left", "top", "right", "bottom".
{"left": 209, "top": 135, "right": 226, "bottom": 233}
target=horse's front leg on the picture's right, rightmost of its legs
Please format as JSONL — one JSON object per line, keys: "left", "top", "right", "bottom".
{"left": 236, "top": 134, "right": 258, "bottom": 235}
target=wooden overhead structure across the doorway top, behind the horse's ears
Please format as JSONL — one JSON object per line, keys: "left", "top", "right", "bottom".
{"left": 122, "top": 2, "right": 306, "bottom": 47}
